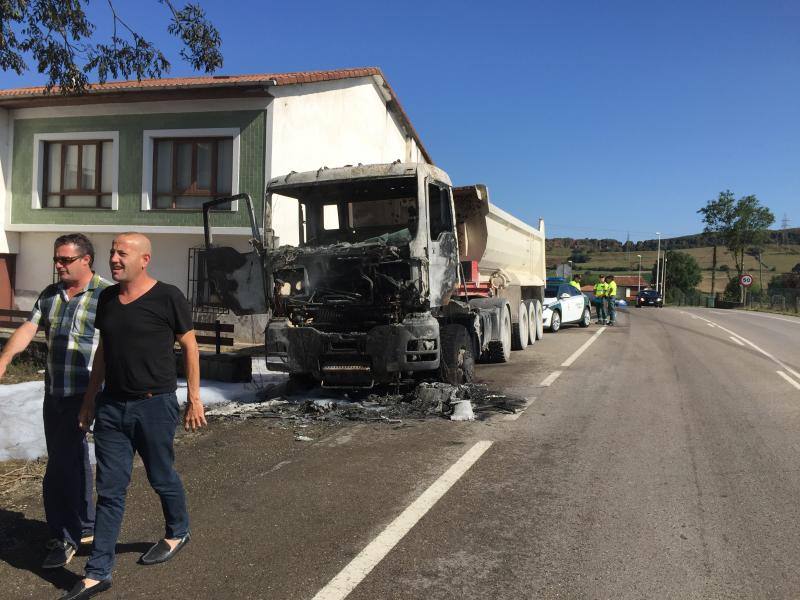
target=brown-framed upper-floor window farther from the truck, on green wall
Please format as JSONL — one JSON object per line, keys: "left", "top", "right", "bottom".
{"left": 41, "top": 139, "right": 115, "bottom": 208}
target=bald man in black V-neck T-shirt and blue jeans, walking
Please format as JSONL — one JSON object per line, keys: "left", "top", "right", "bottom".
{"left": 62, "top": 233, "right": 206, "bottom": 600}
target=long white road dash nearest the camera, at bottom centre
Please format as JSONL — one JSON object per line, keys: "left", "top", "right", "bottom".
{"left": 313, "top": 441, "right": 492, "bottom": 600}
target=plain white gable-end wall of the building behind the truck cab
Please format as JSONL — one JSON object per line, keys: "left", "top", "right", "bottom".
{"left": 267, "top": 78, "right": 421, "bottom": 244}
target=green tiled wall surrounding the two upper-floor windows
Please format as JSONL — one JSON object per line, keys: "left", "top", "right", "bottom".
{"left": 11, "top": 111, "right": 265, "bottom": 227}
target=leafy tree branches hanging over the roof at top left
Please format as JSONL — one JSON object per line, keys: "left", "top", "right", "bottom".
{"left": 0, "top": 0, "right": 222, "bottom": 94}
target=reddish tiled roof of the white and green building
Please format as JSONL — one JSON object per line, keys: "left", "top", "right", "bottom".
{"left": 0, "top": 67, "right": 433, "bottom": 163}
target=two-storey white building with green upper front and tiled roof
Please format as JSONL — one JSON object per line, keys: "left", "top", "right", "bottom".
{"left": 0, "top": 68, "right": 430, "bottom": 324}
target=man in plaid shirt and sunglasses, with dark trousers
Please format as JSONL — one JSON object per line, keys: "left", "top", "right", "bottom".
{"left": 0, "top": 233, "right": 110, "bottom": 569}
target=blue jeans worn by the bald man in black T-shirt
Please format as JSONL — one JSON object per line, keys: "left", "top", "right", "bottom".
{"left": 86, "top": 392, "right": 189, "bottom": 580}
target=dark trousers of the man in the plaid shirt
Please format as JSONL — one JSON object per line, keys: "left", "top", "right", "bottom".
{"left": 42, "top": 394, "right": 94, "bottom": 548}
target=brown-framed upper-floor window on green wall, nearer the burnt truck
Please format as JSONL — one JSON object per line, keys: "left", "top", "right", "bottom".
{"left": 152, "top": 137, "right": 233, "bottom": 210}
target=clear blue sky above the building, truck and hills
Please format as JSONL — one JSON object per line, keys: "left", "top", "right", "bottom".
{"left": 0, "top": 0, "right": 800, "bottom": 240}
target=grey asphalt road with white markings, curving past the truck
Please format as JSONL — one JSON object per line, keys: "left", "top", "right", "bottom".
{"left": 0, "top": 308, "right": 800, "bottom": 600}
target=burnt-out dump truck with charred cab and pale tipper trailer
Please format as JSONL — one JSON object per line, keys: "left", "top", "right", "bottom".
{"left": 202, "top": 162, "right": 546, "bottom": 388}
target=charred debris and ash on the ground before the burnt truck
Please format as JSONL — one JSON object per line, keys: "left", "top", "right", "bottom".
{"left": 206, "top": 382, "right": 525, "bottom": 424}
